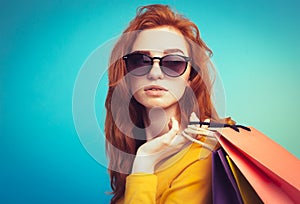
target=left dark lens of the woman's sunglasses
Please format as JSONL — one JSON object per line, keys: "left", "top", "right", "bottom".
{"left": 126, "top": 54, "right": 151, "bottom": 76}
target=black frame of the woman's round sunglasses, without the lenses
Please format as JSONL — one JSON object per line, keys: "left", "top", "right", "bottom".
{"left": 122, "top": 53, "right": 191, "bottom": 77}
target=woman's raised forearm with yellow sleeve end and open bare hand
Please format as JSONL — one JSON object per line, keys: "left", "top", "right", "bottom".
{"left": 124, "top": 118, "right": 180, "bottom": 204}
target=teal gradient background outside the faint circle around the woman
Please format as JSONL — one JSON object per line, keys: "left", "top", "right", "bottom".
{"left": 0, "top": 0, "right": 300, "bottom": 203}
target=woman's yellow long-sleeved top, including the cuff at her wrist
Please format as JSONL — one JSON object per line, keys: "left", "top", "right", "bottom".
{"left": 117, "top": 143, "right": 212, "bottom": 204}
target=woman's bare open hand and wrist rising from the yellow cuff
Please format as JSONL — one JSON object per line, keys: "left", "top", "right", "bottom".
{"left": 131, "top": 118, "right": 189, "bottom": 173}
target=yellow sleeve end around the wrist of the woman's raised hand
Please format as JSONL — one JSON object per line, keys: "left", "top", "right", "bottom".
{"left": 124, "top": 173, "right": 157, "bottom": 204}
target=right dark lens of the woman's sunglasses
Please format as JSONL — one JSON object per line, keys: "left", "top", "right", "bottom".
{"left": 161, "top": 55, "right": 187, "bottom": 77}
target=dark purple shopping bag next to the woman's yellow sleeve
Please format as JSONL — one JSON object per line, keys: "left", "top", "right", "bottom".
{"left": 212, "top": 148, "right": 243, "bottom": 204}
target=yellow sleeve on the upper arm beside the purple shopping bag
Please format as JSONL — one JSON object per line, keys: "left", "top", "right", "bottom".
{"left": 159, "top": 156, "right": 212, "bottom": 204}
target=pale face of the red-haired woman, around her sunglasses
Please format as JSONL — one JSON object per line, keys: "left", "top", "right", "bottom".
{"left": 129, "top": 27, "right": 191, "bottom": 109}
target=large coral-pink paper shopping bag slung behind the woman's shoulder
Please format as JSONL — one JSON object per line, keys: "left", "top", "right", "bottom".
{"left": 218, "top": 127, "right": 300, "bottom": 204}
